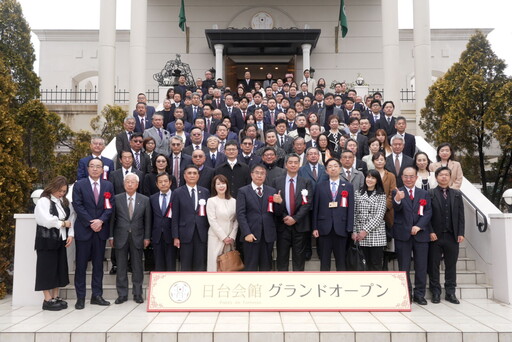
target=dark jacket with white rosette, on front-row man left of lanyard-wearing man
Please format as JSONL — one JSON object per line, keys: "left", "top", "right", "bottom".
{"left": 272, "top": 175, "right": 314, "bottom": 233}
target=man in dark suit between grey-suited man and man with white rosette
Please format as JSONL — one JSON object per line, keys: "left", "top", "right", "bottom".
{"left": 149, "top": 173, "right": 176, "bottom": 271}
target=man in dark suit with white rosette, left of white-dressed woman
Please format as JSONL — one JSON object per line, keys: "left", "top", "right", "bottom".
{"left": 172, "top": 165, "right": 210, "bottom": 271}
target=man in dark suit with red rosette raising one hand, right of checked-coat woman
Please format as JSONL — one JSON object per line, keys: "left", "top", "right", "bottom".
{"left": 391, "top": 166, "right": 432, "bottom": 305}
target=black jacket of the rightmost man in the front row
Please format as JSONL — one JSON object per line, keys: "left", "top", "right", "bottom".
{"left": 428, "top": 187, "right": 465, "bottom": 240}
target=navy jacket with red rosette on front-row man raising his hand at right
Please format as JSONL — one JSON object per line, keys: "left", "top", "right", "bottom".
{"left": 392, "top": 186, "right": 432, "bottom": 242}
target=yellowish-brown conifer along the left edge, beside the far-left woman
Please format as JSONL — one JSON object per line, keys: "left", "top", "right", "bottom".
{"left": 0, "top": 58, "right": 35, "bottom": 298}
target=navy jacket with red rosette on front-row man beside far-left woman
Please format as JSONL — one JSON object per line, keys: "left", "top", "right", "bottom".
{"left": 73, "top": 178, "right": 115, "bottom": 241}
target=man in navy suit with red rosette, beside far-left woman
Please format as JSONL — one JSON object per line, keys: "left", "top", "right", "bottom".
{"left": 73, "top": 158, "right": 115, "bottom": 310}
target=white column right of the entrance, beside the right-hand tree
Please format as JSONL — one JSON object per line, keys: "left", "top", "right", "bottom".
{"left": 413, "top": 0, "right": 432, "bottom": 135}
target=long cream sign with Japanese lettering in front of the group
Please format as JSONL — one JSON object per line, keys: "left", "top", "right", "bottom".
{"left": 147, "top": 272, "right": 411, "bottom": 312}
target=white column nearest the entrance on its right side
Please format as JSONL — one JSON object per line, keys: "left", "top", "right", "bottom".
{"left": 382, "top": 0, "right": 401, "bottom": 115}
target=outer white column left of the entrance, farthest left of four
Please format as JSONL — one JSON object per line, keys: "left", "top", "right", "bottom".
{"left": 98, "top": 0, "right": 116, "bottom": 114}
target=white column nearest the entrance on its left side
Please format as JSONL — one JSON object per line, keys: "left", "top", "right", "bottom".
{"left": 128, "top": 0, "right": 148, "bottom": 113}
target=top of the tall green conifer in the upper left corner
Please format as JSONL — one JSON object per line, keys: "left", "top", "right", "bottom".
{"left": 0, "top": 0, "right": 41, "bottom": 108}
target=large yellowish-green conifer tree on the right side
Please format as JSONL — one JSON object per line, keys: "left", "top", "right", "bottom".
{"left": 420, "top": 31, "right": 512, "bottom": 203}
